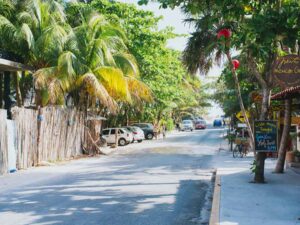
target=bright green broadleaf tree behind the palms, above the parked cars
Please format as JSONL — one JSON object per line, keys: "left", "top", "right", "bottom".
{"left": 67, "top": 0, "right": 209, "bottom": 125}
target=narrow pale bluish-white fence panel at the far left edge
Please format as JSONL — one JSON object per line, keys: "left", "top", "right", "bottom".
{"left": 0, "top": 109, "right": 8, "bottom": 174}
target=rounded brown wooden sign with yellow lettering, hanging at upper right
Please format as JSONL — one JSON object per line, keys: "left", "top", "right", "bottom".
{"left": 272, "top": 55, "right": 300, "bottom": 88}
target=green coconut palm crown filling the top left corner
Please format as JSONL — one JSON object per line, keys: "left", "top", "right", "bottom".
{"left": 0, "top": 0, "right": 67, "bottom": 64}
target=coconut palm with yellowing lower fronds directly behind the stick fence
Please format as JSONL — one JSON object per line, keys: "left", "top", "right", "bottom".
{"left": 35, "top": 13, "right": 151, "bottom": 112}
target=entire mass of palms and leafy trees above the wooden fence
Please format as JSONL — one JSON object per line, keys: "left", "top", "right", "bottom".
{"left": 0, "top": 0, "right": 206, "bottom": 124}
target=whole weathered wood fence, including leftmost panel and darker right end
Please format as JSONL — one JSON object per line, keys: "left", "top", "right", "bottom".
{"left": 0, "top": 107, "right": 106, "bottom": 174}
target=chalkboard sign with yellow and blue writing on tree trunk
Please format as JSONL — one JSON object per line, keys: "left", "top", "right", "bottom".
{"left": 254, "top": 120, "right": 277, "bottom": 152}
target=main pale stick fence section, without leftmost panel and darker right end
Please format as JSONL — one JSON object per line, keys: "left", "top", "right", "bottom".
{"left": 12, "top": 107, "right": 84, "bottom": 169}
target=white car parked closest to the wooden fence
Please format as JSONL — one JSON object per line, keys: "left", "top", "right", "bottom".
{"left": 102, "top": 128, "right": 133, "bottom": 146}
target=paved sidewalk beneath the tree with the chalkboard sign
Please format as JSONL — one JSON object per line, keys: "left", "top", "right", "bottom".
{"left": 214, "top": 151, "right": 300, "bottom": 225}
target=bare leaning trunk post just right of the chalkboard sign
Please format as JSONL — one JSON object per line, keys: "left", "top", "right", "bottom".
{"left": 274, "top": 99, "right": 292, "bottom": 173}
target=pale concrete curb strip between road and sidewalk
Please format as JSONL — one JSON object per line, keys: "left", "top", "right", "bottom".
{"left": 209, "top": 174, "right": 221, "bottom": 225}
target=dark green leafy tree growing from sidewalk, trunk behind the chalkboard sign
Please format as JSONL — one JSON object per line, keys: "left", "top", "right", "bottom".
{"left": 140, "top": 0, "right": 300, "bottom": 183}
